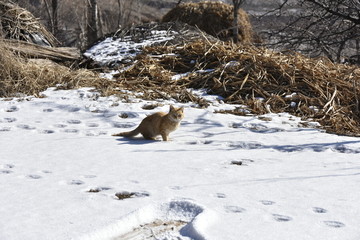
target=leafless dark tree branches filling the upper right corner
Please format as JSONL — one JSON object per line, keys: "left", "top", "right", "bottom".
{"left": 262, "top": 0, "right": 360, "bottom": 62}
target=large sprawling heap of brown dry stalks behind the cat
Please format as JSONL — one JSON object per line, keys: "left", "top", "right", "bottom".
{"left": 113, "top": 41, "right": 360, "bottom": 136}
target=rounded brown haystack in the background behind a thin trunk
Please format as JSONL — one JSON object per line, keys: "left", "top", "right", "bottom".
{"left": 162, "top": 1, "right": 253, "bottom": 43}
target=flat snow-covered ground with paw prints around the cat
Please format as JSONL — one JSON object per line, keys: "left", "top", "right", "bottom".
{"left": 0, "top": 89, "right": 360, "bottom": 240}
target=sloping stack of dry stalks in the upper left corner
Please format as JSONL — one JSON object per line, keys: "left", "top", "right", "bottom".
{"left": 0, "top": 0, "right": 59, "bottom": 47}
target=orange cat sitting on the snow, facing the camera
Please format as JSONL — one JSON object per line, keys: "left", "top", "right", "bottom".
{"left": 112, "top": 106, "right": 184, "bottom": 141}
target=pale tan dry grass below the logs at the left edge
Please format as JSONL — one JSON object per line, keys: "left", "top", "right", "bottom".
{"left": 0, "top": 41, "right": 106, "bottom": 97}
